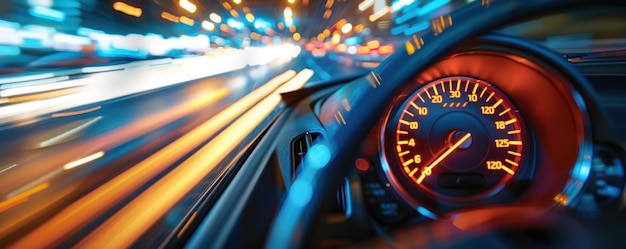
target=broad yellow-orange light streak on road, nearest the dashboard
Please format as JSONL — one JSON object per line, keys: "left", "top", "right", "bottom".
{"left": 77, "top": 69, "right": 313, "bottom": 248}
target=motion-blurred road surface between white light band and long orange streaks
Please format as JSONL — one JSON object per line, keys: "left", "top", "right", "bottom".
{"left": 0, "top": 50, "right": 365, "bottom": 242}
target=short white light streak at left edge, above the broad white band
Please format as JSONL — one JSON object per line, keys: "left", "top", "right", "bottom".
{"left": 0, "top": 75, "right": 74, "bottom": 97}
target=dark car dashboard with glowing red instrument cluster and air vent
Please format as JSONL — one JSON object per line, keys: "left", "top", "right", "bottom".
{"left": 184, "top": 1, "right": 626, "bottom": 248}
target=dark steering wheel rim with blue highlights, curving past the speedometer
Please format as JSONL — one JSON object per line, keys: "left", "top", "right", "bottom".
{"left": 265, "top": 0, "right": 610, "bottom": 248}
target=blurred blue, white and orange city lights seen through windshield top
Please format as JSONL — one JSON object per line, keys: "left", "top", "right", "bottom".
{"left": 0, "top": 0, "right": 472, "bottom": 79}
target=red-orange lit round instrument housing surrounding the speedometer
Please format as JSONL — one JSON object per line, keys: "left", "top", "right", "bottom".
{"left": 348, "top": 38, "right": 592, "bottom": 222}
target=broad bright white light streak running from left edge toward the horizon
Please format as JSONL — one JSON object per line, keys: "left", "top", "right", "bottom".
{"left": 0, "top": 45, "right": 284, "bottom": 124}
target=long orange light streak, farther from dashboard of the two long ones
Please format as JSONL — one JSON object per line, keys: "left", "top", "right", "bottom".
{"left": 12, "top": 70, "right": 296, "bottom": 248}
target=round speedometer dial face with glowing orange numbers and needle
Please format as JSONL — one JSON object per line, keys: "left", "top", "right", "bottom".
{"left": 384, "top": 77, "right": 527, "bottom": 200}
